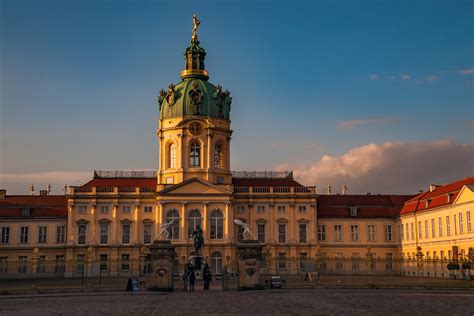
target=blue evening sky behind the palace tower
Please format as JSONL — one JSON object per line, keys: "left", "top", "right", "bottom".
{"left": 0, "top": 0, "right": 474, "bottom": 193}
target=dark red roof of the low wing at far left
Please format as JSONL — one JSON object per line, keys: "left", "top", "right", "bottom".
{"left": 0, "top": 195, "right": 67, "bottom": 219}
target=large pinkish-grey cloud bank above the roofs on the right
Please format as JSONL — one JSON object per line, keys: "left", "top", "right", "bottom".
{"left": 276, "top": 140, "right": 474, "bottom": 194}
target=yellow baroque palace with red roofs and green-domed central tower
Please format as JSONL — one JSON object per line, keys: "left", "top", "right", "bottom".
{"left": 0, "top": 17, "right": 474, "bottom": 278}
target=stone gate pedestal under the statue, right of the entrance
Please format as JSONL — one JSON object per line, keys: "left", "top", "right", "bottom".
{"left": 237, "top": 240, "right": 263, "bottom": 291}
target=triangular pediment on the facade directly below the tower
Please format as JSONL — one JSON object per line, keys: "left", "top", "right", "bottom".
{"left": 159, "top": 178, "right": 232, "bottom": 195}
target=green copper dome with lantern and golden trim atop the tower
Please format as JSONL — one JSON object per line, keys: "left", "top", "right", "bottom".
{"left": 158, "top": 26, "right": 232, "bottom": 120}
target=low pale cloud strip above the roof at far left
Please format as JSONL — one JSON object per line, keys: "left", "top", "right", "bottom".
{"left": 0, "top": 171, "right": 93, "bottom": 194}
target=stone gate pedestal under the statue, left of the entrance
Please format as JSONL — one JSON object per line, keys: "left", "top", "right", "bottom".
{"left": 148, "top": 240, "right": 174, "bottom": 292}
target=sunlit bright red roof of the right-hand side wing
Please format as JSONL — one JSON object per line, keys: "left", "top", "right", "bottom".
{"left": 400, "top": 177, "right": 474, "bottom": 215}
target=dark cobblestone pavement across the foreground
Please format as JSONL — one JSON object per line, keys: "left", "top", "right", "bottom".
{"left": 0, "top": 289, "right": 474, "bottom": 316}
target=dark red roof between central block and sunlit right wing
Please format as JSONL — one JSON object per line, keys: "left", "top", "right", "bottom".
{"left": 317, "top": 195, "right": 412, "bottom": 218}
